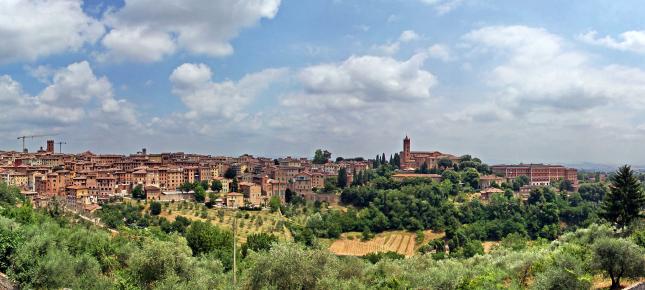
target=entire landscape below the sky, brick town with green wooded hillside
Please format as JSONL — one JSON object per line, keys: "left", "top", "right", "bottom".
{"left": 0, "top": 136, "right": 645, "bottom": 289}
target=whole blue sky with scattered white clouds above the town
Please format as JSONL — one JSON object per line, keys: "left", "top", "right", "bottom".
{"left": 0, "top": 0, "right": 645, "bottom": 164}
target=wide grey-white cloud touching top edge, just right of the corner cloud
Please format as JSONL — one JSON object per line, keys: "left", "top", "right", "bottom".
{"left": 99, "top": 0, "right": 280, "bottom": 62}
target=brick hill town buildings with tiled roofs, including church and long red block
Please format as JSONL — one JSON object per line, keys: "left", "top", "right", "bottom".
{"left": 0, "top": 136, "right": 578, "bottom": 211}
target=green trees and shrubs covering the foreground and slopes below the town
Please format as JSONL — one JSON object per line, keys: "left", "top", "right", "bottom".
{"left": 0, "top": 164, "right": 645, "bottom": 289}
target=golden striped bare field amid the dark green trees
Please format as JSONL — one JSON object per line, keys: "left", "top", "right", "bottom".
{"left": 329, "top": 230, "right": 444, "bottom": 257}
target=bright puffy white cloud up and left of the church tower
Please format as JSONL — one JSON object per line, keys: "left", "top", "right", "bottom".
{"left": 282, "top": 54, "right": 436, "bottom": 108}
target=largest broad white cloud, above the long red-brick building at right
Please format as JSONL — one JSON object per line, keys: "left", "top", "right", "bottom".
{"left": 464, "top": 26, "right": 645, "bottom": 120}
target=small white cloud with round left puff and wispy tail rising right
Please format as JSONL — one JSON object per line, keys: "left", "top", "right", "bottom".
{"left": 170, "top": 63, "right": 286, "bottom": 119}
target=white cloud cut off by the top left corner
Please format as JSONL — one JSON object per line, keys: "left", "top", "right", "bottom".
{"left": 0, "top": 0, "right": 104, "bottom": 63}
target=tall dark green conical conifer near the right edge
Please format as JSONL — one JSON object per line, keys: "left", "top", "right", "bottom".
{"left": 602, "top": 165, "right": 645, "bottom": 229}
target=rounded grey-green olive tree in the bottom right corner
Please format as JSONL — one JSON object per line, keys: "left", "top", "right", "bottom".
{"left": 592, "top": 238, "right": 645, "bottom": 289}
